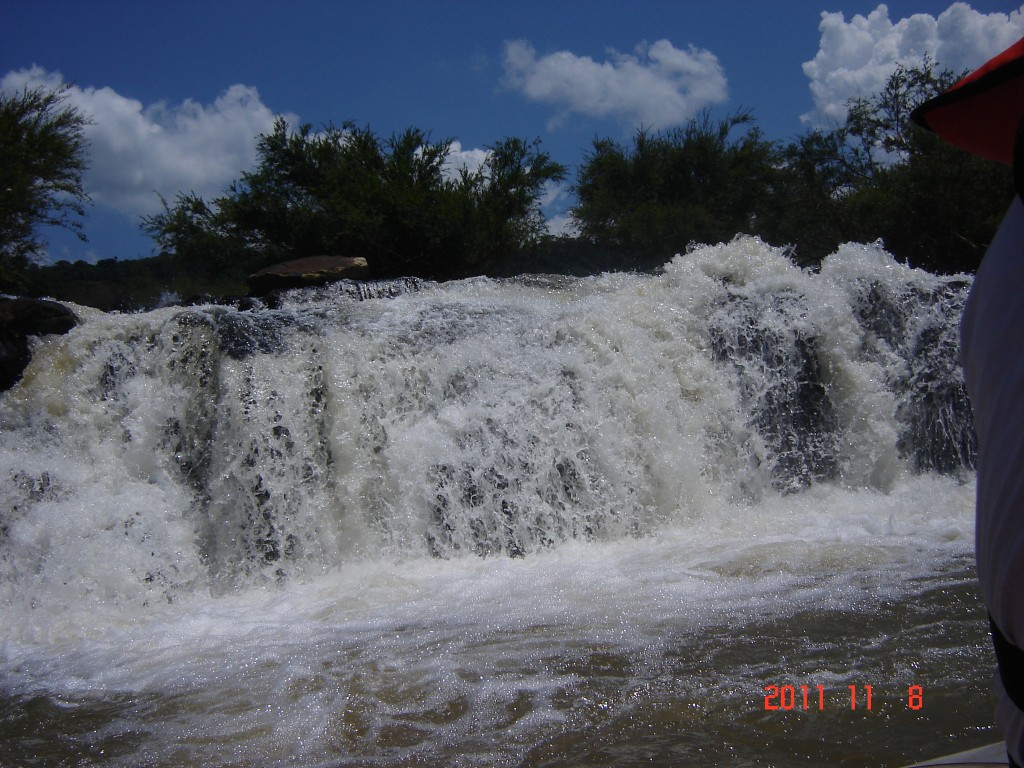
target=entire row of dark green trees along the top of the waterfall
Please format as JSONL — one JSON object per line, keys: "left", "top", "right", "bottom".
{"left": 0, "top": 58, "right": 1014, "bottom": 305}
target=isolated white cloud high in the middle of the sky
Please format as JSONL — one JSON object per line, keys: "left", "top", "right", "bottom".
{"left": 504, "top": 40, "right": 728, "bottom": 129}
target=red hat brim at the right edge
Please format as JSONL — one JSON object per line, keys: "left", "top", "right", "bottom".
{"left": 910, "top": 38, "right": 1024, "bottom": 165}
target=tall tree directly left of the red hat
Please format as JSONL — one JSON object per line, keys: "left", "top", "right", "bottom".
{"left": 770, "top": 57, "right": 1013, "bottom": 272}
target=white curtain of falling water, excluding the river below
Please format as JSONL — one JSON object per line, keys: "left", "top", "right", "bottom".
{"left": 0, "top": 239, "right": 976, "bottom": 601}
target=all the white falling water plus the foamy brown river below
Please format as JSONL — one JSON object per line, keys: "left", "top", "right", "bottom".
{"left": 0, "top": 238, "right": 991, "bottom": 766}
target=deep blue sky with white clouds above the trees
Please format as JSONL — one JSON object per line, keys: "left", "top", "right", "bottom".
{"left": 0, "top": 0, "right": 1024, "bottom": 261}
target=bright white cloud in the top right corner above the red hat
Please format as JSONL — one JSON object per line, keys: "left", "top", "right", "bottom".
{"left": 803, "top": 2, "right": 1024, "bottom": 122}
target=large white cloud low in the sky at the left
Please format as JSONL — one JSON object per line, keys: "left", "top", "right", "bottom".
{"left": 0, "top": 67, "right": 288, "bottom": 216}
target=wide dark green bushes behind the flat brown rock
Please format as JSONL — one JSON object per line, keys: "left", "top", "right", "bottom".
{"left": 143, "top": 119, "right": 564, "bottom": 279}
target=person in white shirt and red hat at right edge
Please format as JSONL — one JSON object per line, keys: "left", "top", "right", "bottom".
{"left": 912, "top": 39, "right": 1024, "bottom": 768}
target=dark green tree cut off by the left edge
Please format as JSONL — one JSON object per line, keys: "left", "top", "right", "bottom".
{"left": 0, "top": 85, "right": 89, "bottom": 290}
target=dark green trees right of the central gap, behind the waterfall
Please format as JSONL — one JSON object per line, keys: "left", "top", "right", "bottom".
{"left": 572, "top": 58, "right": 1013, "bottom": 272}
